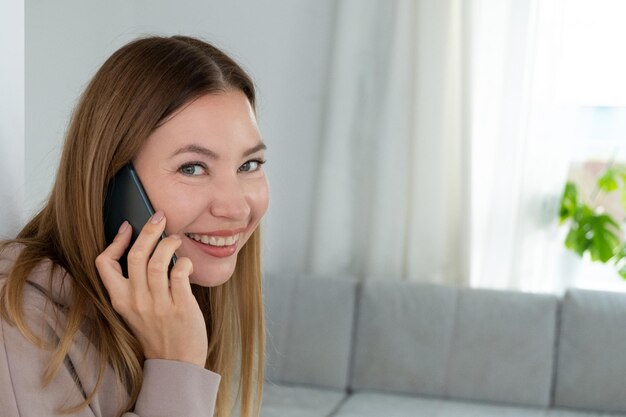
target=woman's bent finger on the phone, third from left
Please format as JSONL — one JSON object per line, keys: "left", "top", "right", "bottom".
{"left": 148, "top": 235, "right": 182, "bottom": 303}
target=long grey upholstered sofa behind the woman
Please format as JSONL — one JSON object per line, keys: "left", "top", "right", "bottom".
{"left": 261, "top": 275, "right": 626, "bottom": 417}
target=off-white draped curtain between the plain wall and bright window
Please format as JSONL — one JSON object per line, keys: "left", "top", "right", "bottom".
{"left": 309, "top": 0, "right": 470, "bottom": 284}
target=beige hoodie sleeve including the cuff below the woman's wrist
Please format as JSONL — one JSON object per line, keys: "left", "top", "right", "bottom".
{"left": 0, "top": 286, "right": 220, "bottom": 417}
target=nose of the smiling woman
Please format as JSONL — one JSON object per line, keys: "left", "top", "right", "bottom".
{"left": 209, "top": 180, "right": 250, "bottom": 220}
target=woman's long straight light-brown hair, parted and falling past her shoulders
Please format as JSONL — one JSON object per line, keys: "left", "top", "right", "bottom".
{"left": 0, "top": 36, "right": 265, "bottom": 417}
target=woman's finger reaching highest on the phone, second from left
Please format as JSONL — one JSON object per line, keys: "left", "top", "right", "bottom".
{"left": 128, "top": 210, "right": 166, "bottom": 294}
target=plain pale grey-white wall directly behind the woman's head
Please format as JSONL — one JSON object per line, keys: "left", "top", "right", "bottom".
{"left": 26, "top": 0, "right": 336, "bottom": 270}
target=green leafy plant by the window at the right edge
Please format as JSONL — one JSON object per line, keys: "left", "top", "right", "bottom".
{"left": 559, "top": 166, "right": 626, "bottom": 279}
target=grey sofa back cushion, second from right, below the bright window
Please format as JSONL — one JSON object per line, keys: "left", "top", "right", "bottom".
{"left": 447, "top": 288, "right": 558, "bottom": 406}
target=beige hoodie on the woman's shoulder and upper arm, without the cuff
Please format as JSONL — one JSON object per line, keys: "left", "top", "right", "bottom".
{"left": 0, "top": 245, "right": 127, "bottom": 416}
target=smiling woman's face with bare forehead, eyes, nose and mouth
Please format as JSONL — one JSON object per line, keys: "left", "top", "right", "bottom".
{"left": 133, "top": 90, "right": 269, "bottom": 287}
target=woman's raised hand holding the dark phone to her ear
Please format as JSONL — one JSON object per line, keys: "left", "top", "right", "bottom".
{"left": 96, "top": 211, "right": 208, "bottom": 367}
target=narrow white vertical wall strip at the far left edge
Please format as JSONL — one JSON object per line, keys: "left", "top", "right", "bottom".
{"left": 0, "top": 0, "right": 24, "bottom": 239}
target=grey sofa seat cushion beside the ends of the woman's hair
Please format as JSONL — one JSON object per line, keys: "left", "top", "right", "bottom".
{"left": 261, "top": 383, "right": 345, "bottom": 417}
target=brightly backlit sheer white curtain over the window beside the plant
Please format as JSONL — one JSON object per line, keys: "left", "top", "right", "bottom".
{"left": 471, "top": 0, "right": 572, "bottom": 292}
